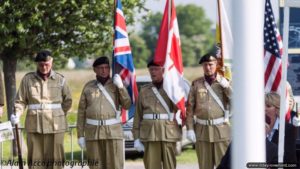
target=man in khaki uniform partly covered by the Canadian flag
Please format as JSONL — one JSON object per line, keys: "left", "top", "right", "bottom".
{"left": 132, "top": 61, "right": 181, "bottom": 169}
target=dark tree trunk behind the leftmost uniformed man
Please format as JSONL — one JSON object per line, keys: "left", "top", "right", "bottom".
{"left": 2, "top": 56, "right": 18, "bottom": 156}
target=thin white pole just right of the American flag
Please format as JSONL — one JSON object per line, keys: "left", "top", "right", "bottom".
{"left": 278, "top": 1, "right": 290, "bottom": 163}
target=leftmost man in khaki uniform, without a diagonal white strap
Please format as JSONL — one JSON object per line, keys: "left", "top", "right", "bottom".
{"left": 11, "top": 51, "right": 72, "bottom": 168}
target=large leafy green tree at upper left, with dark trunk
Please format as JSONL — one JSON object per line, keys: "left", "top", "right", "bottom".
{"left": 0, "top": 0, "right": 144, "bottom": 117}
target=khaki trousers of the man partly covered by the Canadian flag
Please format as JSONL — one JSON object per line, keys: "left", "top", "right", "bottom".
{"left": 143, "top": 141, "right": 176, "bottom": 169}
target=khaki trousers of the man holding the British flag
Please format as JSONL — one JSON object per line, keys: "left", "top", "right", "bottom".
{"left": 86, "top": 139, "right": 124, "bottom": 169}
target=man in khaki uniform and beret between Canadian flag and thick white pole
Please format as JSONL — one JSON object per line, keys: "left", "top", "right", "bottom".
{"left": 186, "top": 54, "right": 231, "bottom": 169}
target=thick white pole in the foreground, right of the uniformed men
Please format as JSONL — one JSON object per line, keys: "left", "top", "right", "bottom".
{"left": 232, "top": 0, "right": 266, "bottom": 169}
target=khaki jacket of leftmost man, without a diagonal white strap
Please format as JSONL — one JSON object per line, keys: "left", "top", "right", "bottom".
{"left": 15, "top": 70, "right": 72, "bottom": 134}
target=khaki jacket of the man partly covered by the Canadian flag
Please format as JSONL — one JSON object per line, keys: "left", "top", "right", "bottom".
{"left": 132, "top": 83, "right": 181, "bottom": 142}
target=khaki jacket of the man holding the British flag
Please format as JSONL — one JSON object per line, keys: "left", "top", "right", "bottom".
{"left": 77, "top": 79, "right": 131, "bottom": 140}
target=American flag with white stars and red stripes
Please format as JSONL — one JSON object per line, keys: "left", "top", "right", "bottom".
{"left": 264, "top": 0, "right": 290, "bottom": 120}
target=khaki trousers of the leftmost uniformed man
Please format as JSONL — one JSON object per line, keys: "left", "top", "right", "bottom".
{"left": 27, "top": 132, "right": 65, "bottom": 169}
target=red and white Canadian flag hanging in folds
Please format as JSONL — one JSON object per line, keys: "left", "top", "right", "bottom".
{"left": 154, "top": 0, "right": 187, "bottom": 122}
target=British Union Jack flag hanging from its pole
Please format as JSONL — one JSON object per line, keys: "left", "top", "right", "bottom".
{"left": 113, "top": 0, "right": 138, "bottom": 123}
